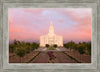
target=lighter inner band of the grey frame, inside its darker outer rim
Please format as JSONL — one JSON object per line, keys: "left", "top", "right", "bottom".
{"left": 3, "top": 3, "right": 97, "bottom": 69}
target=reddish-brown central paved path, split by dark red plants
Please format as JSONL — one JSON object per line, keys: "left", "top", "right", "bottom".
{"left": 31, "top": 52, "right": 76, "bottom": 63}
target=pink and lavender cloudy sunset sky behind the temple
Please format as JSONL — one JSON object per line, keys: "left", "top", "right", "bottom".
{"left": 8, "top": 8, "right": 92, "bottom": 43}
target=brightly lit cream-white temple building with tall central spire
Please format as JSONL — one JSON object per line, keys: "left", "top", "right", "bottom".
{"left": 40, "top": 20, "right": 63, "bottom": 47}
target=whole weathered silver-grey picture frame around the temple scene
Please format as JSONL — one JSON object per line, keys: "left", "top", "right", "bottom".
{"left": 0, "top": 0, "right": 99, "bottom": 72}
